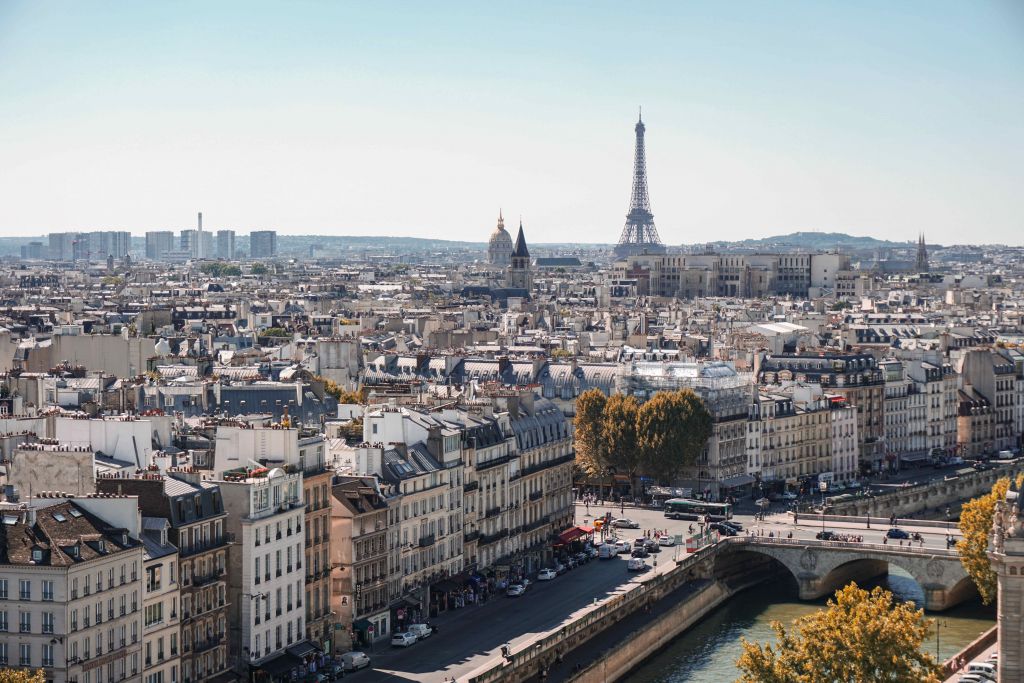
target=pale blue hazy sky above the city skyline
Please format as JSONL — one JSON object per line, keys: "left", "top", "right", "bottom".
{"left": 0, "top": 0, "right": 1024, "bottom": 245}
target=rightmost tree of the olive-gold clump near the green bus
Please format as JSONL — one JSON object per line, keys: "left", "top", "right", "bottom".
{"left": 637, "top": 389, "right": 712, "bottom": 484}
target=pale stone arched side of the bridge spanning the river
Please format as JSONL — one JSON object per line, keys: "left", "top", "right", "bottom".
{"left": 715, "top": 537, "right": 976, "bottom": 611}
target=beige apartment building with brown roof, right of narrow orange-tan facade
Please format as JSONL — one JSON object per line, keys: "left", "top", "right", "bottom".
{"left": 331, "top": 477, "right": 396, "bottom": 653}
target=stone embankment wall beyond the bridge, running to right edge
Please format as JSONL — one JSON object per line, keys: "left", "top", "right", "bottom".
{"left": 827, "top": 463, "right": 1024, "bottom": 523}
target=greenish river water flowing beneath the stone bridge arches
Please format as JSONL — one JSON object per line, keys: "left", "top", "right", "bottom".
{"left": 626, "top": 567, "right": 995, "bottom": 683}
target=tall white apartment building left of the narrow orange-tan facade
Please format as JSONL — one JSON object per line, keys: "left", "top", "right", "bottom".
{"left": 218, "top": 465, "right": 309, "bottom": 676}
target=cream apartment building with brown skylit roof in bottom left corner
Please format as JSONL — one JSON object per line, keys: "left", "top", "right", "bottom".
{"left": 0, "top": 494, "right": 144, "bottom": 683}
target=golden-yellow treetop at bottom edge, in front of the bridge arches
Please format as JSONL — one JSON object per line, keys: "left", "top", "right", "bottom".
{"left": 736, "top": 584, "right": 941, "bottom": 683}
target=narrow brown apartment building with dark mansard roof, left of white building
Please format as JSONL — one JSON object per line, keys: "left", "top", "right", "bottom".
{"left": 96, "top": 468, "right": 231, "bottom": 683}
